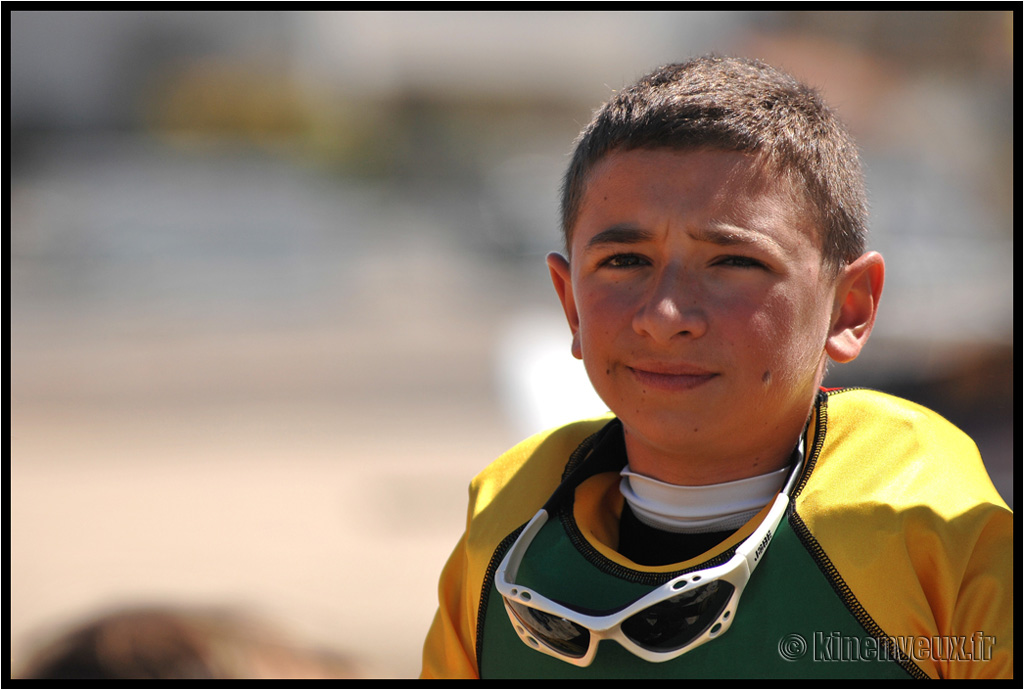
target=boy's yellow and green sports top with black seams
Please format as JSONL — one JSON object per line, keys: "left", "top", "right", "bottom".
{"left": 422, "top": 389, "right": 1014, "bottom": 679}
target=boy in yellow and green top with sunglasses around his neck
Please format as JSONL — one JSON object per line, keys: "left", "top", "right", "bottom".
{"left": 423, "top": 57, "right": 1013, "bottom": 679}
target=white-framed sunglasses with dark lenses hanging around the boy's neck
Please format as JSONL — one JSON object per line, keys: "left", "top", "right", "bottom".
{"left": 495, "top": 448, "right": 802, "bottom": 666}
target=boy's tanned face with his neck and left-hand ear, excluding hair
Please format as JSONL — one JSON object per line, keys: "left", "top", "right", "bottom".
{"left": 549, "top": 149, "right": 837, "bottom": 483}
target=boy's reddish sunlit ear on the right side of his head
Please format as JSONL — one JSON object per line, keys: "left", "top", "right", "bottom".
{"left": 825, "top": 252, "right": 886, "bottom": 363}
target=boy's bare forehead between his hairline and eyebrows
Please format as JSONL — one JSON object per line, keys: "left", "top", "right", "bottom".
{"left": 570, "top": 148, "right": 820, "bottom": 251}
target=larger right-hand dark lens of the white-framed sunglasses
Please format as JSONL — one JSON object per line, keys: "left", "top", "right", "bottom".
{"left": 622, "top": 580, "right": 735, "bottom": 652}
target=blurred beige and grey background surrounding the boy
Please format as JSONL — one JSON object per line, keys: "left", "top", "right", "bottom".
{"left": 6, "top": 11, "right": 1016, "bottom": 678}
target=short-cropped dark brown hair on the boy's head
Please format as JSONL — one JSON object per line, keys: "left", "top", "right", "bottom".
{"left": 561, "top": 55, "right": 867, "bottom": 271}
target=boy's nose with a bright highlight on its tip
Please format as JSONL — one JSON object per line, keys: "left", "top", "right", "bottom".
{"left": 633, "top": 267, "right": 708, "bottom": 343}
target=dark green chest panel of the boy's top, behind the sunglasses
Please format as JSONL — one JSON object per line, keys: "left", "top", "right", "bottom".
{"left": 477, "top": 509, "right": 910, "bottom": 679}
